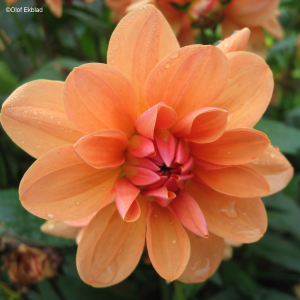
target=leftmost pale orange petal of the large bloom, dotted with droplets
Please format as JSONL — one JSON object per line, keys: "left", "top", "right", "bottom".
{"left": 1, "top": 79, "right": 83, "bottom": 157}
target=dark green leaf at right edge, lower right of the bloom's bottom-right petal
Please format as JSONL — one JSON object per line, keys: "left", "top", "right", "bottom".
{"left": 247, "top": 233, "right": 300, "bottom": 272}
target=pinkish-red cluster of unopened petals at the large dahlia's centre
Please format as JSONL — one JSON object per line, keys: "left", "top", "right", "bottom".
{"left": 123, "top": 129, "right": 194, "bottom": 206}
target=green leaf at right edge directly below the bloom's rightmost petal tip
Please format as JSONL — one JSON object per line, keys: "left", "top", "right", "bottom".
{"left": 263, "top": 193, "right": 300, "bottom": 240}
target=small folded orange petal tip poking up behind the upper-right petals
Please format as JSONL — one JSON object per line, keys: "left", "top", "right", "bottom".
{"left": 217, "top": 27, "right": 250, "bottom": 53}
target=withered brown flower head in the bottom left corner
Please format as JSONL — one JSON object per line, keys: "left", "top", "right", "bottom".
{"left": 2, "top": 244, "right": 63, "bottom": 288}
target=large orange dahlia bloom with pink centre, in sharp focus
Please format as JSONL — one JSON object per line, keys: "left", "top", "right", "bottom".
{"left": 1, "top": 5, "right": 293, "bottom": 287}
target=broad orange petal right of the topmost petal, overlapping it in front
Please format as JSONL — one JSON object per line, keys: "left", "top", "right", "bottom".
{"left": 146, "top": 45, "right": 229, "bottom": 118}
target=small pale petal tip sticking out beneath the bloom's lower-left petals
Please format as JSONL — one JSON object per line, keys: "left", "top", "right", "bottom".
{"left": 41, "top": 221, "right": 81, "bottom": 239}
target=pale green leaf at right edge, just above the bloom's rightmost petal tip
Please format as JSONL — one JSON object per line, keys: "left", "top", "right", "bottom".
{"left": 255, "top": 118, "right": 300, "bottom": 154}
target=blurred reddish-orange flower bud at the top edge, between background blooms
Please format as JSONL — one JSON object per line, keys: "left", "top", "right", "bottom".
{"left": 188, "top": 0, "right": 222, "bottom": 27}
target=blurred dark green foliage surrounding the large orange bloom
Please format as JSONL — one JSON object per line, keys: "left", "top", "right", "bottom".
{"left": 0, "top": 0, "right": 300, "bottom": 300}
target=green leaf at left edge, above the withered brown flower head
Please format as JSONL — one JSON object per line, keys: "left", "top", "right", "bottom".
{"left": 0, "top": 189, "right": 75, "bottom": 246}
